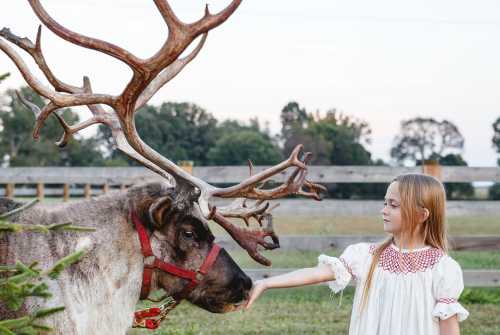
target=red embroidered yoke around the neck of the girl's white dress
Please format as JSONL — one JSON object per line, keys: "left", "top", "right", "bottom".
{"left": 370, "top": 244, "right": 444, "bottom": 274}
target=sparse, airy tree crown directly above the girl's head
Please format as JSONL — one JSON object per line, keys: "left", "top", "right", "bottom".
{"left": 391, "top": 117, "right": 464, "bottom": 165}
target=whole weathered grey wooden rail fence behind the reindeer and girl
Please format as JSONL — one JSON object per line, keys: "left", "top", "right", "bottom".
{"left": 0, "top": 166, "right": 500, "bottom": 287}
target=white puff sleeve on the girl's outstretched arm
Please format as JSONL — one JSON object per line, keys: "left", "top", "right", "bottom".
{"left": 318, "top": 243, "right": 369, "bottom": 293}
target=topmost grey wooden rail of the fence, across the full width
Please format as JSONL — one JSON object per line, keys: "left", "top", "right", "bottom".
{"left": 0, "top": 166, "right": 500, "bottom": 185}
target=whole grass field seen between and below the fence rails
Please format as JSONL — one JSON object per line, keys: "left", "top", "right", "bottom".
{"left": 130, "top": 216, "right": 500, "bottom": 335}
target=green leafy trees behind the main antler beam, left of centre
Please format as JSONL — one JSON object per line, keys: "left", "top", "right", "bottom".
{"left": 98, "top": 103, "right": 281, "bottom": 166}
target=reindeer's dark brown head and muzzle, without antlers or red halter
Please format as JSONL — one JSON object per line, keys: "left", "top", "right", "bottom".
{"left": 131, "top": 183, "right": 252, "bottom": 313}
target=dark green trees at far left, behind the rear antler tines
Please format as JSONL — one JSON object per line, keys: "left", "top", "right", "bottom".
{"left": 0, "top": 87, "right": 102, "bottom": 166}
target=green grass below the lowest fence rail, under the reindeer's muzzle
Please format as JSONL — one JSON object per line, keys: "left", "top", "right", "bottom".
{"left": 129, "top": 287, "right": 500, "bottom": 335}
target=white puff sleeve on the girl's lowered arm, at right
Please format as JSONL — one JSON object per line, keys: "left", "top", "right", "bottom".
{"left": 432, "top": 256, "right": 469, "bottom": 321}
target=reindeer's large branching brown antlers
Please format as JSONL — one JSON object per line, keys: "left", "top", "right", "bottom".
{"left": 0, "top": 0, "right": 324, "bottom": 265}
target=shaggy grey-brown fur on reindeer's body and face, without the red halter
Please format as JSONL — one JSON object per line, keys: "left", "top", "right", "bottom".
{"left": 0, "top": 183, "right": 252, "bottom": 334}
